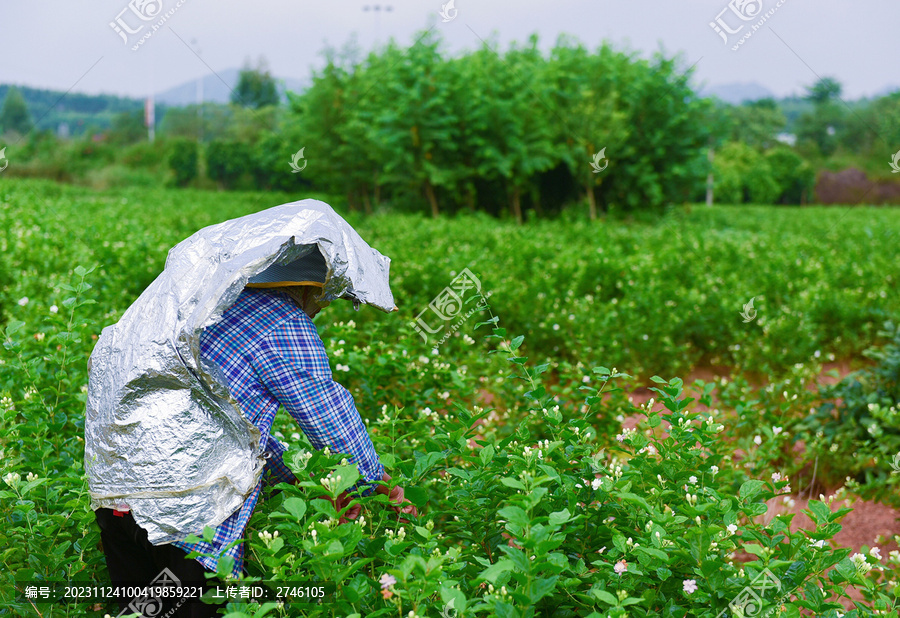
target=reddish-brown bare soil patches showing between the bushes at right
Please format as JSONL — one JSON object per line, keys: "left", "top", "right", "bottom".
{"left": 479, "top": 360, "right": 900, "bottom": 610}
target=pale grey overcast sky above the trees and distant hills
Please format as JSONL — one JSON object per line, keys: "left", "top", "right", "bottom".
{"left": 0, "top": 0, "right": 900, "bottom": 98}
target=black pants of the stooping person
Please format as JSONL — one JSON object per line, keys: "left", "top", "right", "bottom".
{"left": 94, "top": 509, "right": 225, "bottom": 618}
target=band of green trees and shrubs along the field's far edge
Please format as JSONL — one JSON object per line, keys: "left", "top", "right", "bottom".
{"left": 0, "top": 32, "right": 900, "bottom": 221}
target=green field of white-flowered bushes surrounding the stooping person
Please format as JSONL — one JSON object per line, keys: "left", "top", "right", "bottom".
{"left": 0, "top": 180, "right": 900, "bottom": 618}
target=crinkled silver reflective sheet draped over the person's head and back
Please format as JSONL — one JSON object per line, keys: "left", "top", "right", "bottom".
{"left": 84, "top": 200, "right": 396, "bottom": 545}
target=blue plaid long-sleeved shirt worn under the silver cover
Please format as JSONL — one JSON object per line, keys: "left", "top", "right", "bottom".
{"left": 172, "top": 288, "right": 384, "bottom": 577}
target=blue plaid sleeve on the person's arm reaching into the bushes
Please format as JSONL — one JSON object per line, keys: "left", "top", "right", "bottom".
{"left": 253, "top": 314, "right": 384, "bottom": 481}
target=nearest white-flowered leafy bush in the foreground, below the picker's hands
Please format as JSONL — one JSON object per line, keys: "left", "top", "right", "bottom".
{"left": 229, "top": 298, "right": 888, "bottom": 617}
